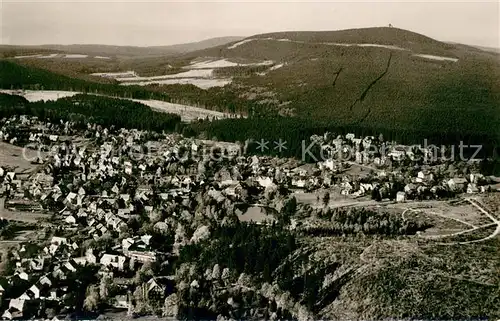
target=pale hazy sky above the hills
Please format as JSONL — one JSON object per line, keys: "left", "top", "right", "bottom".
{"left": 0, "top": 0, "right": 500, "bottom": 48}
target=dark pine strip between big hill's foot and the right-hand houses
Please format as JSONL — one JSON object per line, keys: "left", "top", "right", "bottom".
{"left": 186, "top": 116, "right": 499, "bottom": 162}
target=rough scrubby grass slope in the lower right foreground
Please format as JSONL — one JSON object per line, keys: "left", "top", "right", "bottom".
{"left": 289, "top": 237, "right": 500, "bottom": 320}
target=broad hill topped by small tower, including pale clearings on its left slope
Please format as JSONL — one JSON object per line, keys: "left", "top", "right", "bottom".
{"left": 3, "top": 28, "right": 500, "bottom": 145}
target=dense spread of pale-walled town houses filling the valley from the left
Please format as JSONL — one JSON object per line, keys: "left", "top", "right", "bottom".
{"left": 0, "top": 117, "right": 496, "bottom": 319}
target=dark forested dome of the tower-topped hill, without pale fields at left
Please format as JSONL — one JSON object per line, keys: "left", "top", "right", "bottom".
{"left": 162, "top": 28, "right": 500, "bottom": 142}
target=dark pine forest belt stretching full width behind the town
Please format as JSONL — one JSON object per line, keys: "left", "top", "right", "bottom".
{"left": 0, "top": 90, "right": 500, "bottom": 174}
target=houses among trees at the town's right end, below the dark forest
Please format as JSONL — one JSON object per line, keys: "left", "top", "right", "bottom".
{"left": 311, "top": 133, "right": 498, "bottom": 202}
